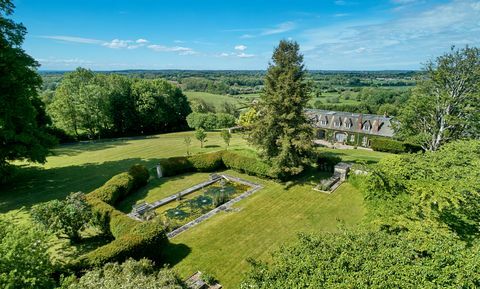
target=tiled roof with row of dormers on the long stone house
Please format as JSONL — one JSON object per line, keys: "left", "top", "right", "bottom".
{"left": 306, "top": 109, "right": 394, "bottom": 137}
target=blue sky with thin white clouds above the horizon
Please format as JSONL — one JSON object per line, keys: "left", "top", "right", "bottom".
{"left": 13, "top": 0, "right": 480, "bottom": 70}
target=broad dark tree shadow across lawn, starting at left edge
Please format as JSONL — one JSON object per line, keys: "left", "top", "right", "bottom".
{"left": 0, "top": 158, "right": 160, "bottom": 213}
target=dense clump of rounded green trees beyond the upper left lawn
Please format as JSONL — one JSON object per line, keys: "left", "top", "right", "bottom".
{"left": 48, "top": 68, "right": 191, "bottom": 137}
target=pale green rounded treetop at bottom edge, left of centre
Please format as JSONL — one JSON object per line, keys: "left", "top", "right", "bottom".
{"left": 62, "top": 259, "right": 184, "bottom": 289}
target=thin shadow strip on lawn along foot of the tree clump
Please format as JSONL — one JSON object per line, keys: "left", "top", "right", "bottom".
{"left": 52, "top": 135, "right": 158, "bottom": 156}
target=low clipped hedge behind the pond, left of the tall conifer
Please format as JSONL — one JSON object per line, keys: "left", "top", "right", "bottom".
{"left": 160, "top": 151, "right": 278, "bottom": 178}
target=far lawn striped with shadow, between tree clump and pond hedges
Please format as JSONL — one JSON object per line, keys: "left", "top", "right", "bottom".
{"left": 0, "top": 132, "right": 246, "bottom": 213}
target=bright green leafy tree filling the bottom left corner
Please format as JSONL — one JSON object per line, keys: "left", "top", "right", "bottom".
{"left": 0, "top": 213, "right": 55, "bottom": 289}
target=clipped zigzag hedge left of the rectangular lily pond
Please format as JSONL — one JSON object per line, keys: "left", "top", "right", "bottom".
{"left": 78, "top": 165, "right": 168, "bottom": 269}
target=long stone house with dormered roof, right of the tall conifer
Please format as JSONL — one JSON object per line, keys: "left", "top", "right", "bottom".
{"left": 305, "top": 109, "right": 394, "bottom": 147}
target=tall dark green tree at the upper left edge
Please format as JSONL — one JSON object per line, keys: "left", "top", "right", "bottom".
{"left": 0, "top": 0, "right": 55, "bottom": 182}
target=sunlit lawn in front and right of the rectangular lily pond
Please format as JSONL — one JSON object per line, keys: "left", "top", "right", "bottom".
{"left": 163, "top": 171, "right": 364, "bottom": 289}
